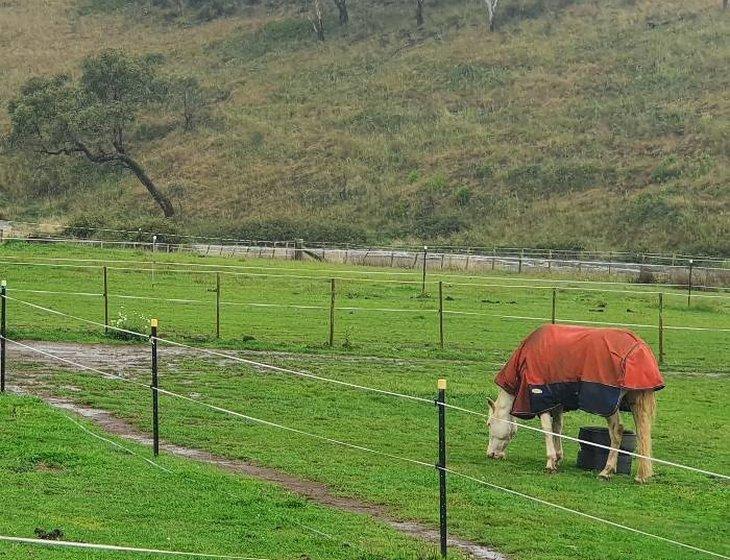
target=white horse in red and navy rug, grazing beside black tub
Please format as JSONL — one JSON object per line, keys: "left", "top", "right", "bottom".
{"left": 487, "top": 325, "right": 664, "bottom": 482}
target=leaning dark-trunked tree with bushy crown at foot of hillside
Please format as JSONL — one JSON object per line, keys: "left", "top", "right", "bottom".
{"left": 8, "top": 50, "right": 182, "bottom": 217}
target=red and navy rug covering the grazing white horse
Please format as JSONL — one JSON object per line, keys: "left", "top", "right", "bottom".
{"left": 495, "top": 325, "right": 664, "bottom": 418}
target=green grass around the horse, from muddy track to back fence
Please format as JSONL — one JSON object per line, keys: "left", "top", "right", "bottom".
{"left": 0, "top": 241, "right": 730, "bottom": 560}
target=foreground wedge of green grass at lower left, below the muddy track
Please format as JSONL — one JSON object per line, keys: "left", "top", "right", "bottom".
{"left": 0, "top": 395, "right": 450, "bottom": 560}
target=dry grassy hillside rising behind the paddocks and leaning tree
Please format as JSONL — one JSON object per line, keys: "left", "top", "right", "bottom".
{"left": 0, "top": 0, "right": 730, "bottom": 253}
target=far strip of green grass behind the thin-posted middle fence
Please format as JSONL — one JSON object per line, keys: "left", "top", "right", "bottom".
{"left": 0, "top": 243, "right": 730, "bottom": 371}
